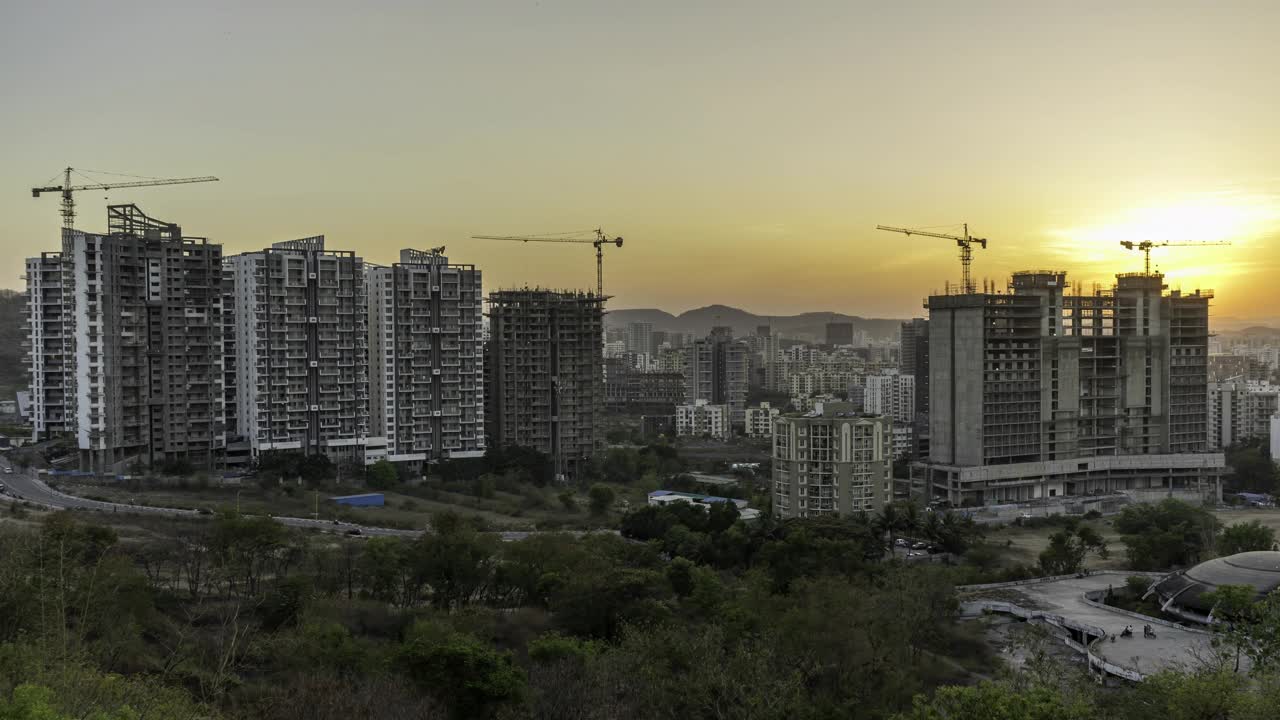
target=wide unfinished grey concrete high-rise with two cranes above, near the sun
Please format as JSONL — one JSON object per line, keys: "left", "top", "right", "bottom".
{"left": 922, "top": 272, "right": 1224, "bottom": 503}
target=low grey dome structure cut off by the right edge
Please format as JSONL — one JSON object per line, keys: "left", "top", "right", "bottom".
{"left": 1152, "top": 550, "right": 1280, "bottom": 623}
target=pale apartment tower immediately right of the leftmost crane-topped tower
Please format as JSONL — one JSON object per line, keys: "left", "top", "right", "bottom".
{"left": 223, "top": 236, "right": 371, "bottom": 462}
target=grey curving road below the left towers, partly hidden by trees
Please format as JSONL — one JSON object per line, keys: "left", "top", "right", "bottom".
{"left": 0, "top": 459, "right": 596, "bottom": 542}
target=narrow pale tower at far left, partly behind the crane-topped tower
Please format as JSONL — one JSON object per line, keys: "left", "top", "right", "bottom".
{"left": 26, "top": 252, "right": 76, "bottom": 441}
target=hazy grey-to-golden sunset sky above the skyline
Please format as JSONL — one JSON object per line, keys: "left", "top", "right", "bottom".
{"left": 0, "top": 0, "right": 1280, "bottom": 319}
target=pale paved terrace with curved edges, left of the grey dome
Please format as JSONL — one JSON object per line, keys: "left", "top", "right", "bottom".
{"left": 961, "top": 573, "right": 1212, "bottom": 675}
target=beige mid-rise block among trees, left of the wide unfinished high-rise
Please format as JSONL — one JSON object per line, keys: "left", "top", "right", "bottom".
{"left": 773, "top": 402, "right": 893, "bottom": 518}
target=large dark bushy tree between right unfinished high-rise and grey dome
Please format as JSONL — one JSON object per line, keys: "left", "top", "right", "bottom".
{"left": 1115, "top": 498, "right": 1221, "bottom": 570}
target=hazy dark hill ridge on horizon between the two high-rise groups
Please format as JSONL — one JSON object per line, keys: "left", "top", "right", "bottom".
{"left": 604, "top": 305, "right": 902, "bottom": 340}
